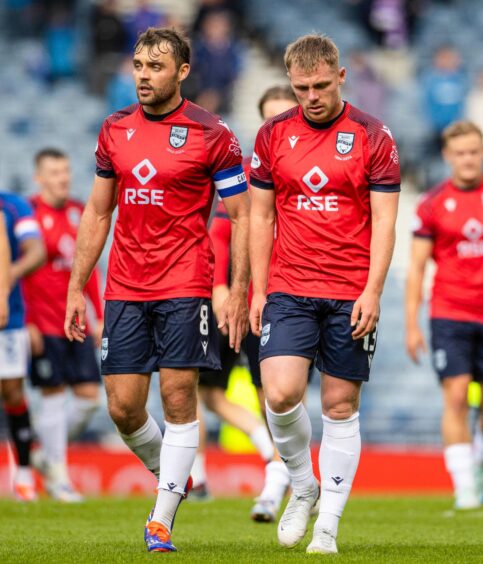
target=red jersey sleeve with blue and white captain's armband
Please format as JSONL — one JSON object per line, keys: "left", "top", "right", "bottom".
{"left": 207, "top": 120, "right": 247, "bottom": 198}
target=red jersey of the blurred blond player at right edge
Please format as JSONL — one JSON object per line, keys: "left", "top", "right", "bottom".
{"left": 413, "top": 180, "right": 483, "bottom": 323}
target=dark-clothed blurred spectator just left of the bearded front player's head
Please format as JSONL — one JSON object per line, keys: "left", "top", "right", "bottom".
{"left": 89, "top": 0, "right": 127, "bottom": 95}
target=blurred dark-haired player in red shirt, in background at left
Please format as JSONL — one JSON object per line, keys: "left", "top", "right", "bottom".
{"left": 24, "top": 148, "right": 103, "bottom": 502}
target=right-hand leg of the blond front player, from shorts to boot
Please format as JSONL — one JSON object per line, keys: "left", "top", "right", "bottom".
{"left": 307, "top": 300, "right": 370, "bottom": 553}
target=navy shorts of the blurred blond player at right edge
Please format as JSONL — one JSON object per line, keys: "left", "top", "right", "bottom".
{"left": 431, "top": 319, "right": 483, "bottom": 382}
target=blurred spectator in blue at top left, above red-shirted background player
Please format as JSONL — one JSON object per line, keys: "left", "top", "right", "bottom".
{"left": 45, "top": 7, "right": 77, "bottom": 82}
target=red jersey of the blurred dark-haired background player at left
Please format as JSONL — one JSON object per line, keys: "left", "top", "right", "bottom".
{"left": 23, "top": 195, "right": 102, "bottom": 337}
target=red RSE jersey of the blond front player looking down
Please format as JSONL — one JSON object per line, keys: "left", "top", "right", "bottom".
{"left": 250, "top": 102, "right": 400, "bottom": 300}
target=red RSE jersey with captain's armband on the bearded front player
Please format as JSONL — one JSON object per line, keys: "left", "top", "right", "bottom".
{"left": 96, "top": 100, "right": 247, "bottom": 301}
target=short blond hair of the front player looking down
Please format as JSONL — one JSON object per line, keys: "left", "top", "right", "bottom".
{"left": 283, "top": 33, "right": 339, "bottom": 72}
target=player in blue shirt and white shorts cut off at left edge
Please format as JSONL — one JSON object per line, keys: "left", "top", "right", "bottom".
{"left": 0, "top": 192, "right": 45, "bottom": 501}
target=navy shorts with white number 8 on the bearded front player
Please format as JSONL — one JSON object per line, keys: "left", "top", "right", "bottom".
{"left": 101, "top": 298, "right": 221, "bottom": 374}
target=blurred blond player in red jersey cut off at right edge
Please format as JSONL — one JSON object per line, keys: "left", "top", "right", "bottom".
{"left": 406, "top": 121, "right": 483, "bottom": 509}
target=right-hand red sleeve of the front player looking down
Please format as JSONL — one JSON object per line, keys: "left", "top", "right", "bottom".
{"left": 368, "top": 123, "right": 401, "bottom": 192}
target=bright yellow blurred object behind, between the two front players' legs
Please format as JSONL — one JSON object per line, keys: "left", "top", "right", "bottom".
{"left": 219, "top": 366, "right": 260, "bottom": 454}
